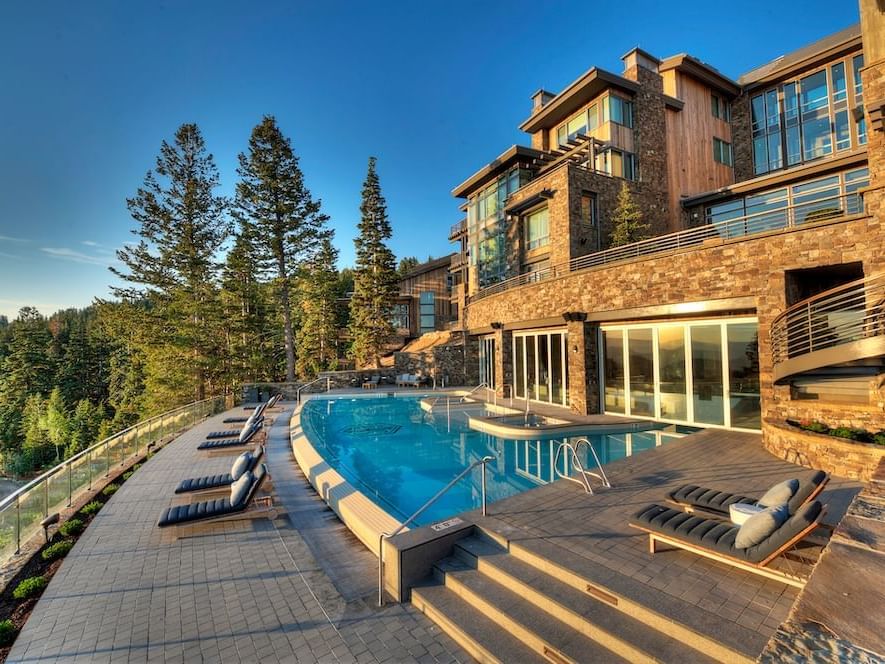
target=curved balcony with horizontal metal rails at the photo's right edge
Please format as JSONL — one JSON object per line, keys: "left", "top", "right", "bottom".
{"left": 771, "top": 272, "right": 885, "bottom": 382}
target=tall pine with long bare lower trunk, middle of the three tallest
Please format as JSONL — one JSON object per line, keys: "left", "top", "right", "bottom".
{"left": 235, "top": 115, "right": 328, "bottom": 381}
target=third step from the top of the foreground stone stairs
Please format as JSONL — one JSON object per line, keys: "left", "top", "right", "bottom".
{"left": 436, "top": 558, "right": 628, "bottom": 664}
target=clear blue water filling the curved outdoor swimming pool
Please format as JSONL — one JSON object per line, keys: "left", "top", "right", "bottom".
{"left": 301, "top": 397, "right": 678, "bottom": 525}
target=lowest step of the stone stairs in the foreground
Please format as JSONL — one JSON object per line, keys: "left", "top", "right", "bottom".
{"left": 412, "top": 585, "right": 550, "bottom": 664}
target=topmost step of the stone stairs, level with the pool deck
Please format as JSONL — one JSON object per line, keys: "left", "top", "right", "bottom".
{"left": 500, "top": 539, "right": 767, "bottom": 662}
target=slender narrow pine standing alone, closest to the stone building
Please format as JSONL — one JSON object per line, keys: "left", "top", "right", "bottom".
{"left": 350, "top": 157, "right": 397, "bottom": 367}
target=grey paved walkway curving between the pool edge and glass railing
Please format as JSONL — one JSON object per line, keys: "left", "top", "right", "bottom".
{"left": 8, "top": 406, "right": 470, "bottom": 662}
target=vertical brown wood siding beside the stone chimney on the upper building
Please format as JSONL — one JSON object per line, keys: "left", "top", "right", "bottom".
{"left": 663, "top": 69, "right": 734, "bottom": 231}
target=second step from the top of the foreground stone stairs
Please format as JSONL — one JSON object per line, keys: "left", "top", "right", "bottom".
{"left": 456, "top": 537, "right": 716, "bottom": 662}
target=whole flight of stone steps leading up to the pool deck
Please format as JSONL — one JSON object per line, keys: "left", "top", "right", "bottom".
{"left": 411, "top": 528, "right": 753, "bottom": 664}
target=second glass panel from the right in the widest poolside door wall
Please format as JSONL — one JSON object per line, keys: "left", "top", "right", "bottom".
{"left": 689, "top": 325, "right": 725, "bottom": 424}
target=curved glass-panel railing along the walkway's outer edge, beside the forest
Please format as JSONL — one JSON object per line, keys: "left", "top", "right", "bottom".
{"left": 0, "top": 396, "right": 225, "bottom": 565}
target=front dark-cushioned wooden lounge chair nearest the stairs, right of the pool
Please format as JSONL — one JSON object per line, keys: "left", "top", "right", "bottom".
{"left": 630, "top": 500, "right": 826, "bottom": 588}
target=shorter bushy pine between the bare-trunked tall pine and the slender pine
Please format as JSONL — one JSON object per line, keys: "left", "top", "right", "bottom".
{"left": 296, "top": 237, "right": 338, "bottom": 377}
